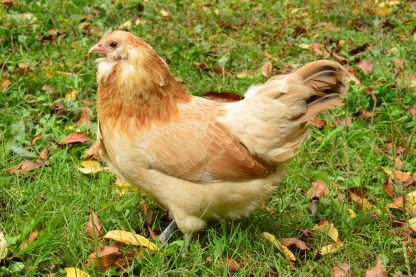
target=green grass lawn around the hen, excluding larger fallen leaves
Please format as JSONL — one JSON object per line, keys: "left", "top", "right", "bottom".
{"left": 0, "top": 0, "right": 416, "bottom": 276}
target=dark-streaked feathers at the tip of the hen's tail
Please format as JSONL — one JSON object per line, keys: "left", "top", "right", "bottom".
{"left": 294, "top": 60, "right": 350, "bottom": 122}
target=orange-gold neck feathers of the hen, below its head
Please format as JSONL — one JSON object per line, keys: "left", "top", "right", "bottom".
{"left": 97, "top": 53, "right": 190, "bottom": 131}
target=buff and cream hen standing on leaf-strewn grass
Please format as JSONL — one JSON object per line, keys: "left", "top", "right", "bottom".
{"left": 89, "top": 31, "right": 349, "bottom": 242}
